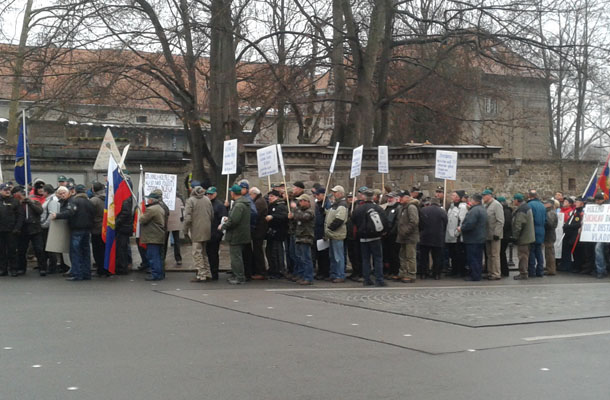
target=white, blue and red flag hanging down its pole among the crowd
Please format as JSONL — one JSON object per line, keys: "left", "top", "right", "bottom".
{"left": 102, "top": 157, "right": 131, "bottom": 274}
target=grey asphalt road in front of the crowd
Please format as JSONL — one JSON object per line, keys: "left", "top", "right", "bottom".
{"left": 0, "top": 273, "right": 610, "bottom": 400}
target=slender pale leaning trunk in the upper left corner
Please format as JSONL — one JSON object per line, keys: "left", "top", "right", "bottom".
{"left": 7, "top": 0, "right": 33, "bottom": 146}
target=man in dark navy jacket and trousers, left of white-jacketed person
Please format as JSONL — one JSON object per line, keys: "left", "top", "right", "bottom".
{"left": 419, "top": 197, "right": 447, "bottom": 280}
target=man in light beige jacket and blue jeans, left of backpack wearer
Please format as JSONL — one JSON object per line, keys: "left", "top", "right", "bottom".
{"left": 324, "top": 185, "right": 347, "bottom": 283}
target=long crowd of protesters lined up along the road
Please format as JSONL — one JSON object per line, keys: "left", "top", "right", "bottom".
{"left": 0, "top": 176, "right": 608, "bottom": 286}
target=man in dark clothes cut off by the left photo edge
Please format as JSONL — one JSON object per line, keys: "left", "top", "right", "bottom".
{"left": 0, "top": 183, "right": 23, "bottom": 276}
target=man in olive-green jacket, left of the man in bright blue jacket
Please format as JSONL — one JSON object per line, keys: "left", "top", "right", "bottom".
{"left": 513, "top": 193, "right": 536, "bottom": 280}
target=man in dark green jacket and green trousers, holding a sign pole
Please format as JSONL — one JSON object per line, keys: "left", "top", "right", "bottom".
{"left": 218, "top": 185, "right": 252, "bottom": 285}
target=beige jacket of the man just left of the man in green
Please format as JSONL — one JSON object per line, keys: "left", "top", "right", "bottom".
{"left": 184, "top": 188, "right": 217, "bottom": 242}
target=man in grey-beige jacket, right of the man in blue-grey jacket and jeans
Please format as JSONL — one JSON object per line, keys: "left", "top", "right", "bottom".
{"left": 482, "top": 189, "right": 504, "bottom": 281}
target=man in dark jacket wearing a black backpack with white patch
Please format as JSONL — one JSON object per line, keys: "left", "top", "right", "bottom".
{"left": 352, "top": 189, "right": 388, "bottom": 286}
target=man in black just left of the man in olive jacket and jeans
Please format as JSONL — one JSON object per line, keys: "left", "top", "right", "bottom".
{"left": 265, "top": 189, "right": 288, "bottom": 279}
